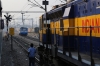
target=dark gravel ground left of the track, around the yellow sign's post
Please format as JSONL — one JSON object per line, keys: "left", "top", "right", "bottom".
{"left": 1, "top": 41, "right": 28, "bottom": 66}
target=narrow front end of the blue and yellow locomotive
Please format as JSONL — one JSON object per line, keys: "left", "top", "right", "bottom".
{"left": 39, "top": 14, "right": 51, "bottom": 47}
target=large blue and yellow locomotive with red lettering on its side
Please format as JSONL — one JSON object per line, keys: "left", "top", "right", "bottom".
{"left": 39, "top": 0, "right": 100, "bottom": 66}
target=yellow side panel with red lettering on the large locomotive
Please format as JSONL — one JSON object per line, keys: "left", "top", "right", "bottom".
{"left": 75, "top": 15, "right": 100, "bottom": 37}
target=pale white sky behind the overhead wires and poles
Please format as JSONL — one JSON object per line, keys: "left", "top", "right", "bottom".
{"left": 1, "top": 0, "right": 63, "bottom": 26}
